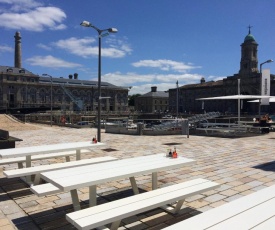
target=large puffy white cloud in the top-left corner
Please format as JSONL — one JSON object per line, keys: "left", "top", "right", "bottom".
{"left": 0, "top": 0, "right": 66, "bottom": 32}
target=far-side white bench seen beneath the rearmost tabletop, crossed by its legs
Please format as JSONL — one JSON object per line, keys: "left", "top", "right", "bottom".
{"left": 0, "top": 149, "right": 91, "bottom": 165}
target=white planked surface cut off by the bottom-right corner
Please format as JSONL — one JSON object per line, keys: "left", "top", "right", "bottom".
{"left": 165, "top": 185, "right": 275, "bottom": 230}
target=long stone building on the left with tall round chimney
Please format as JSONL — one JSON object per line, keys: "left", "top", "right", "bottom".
{"left": 0, "top": 32, "right": 129, "bottom": 111}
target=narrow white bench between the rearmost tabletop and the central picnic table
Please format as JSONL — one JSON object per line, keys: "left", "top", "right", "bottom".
{"left": 3, "top": 156, "right": 117, "bottom": 178}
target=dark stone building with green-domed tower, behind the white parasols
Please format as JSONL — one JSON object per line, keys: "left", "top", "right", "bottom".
{"left": 169, "top": 28, "right": 275, "bottom": 114}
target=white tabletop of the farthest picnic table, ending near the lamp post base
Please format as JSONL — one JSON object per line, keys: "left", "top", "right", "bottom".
{"left": 0, "top": 141, "right": 105, "bottom": 158}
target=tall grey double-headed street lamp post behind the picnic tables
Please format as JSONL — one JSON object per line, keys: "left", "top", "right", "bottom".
{"left": 80, "top": 21, "right": 118, "bottom": 142}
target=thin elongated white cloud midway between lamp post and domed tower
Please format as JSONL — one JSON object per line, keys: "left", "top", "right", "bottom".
{"left": 132, "top": 59, "right": 201, "bottom": 73}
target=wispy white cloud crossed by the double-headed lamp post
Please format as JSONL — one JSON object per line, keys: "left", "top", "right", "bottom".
{"left": 52, "top": 37, "right": 130, "bottom": 58}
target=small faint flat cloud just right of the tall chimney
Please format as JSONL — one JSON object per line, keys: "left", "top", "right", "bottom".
{"left": 26, "top": 55, "right": 82, "bottom": 68}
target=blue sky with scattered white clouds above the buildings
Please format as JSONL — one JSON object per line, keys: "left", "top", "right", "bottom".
{"left": 0, "top": 0, "right": 275, "bottom": 95}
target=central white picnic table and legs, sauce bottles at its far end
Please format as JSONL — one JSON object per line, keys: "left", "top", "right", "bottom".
{"left": 41, "top": 153, "right": 195, "bottom": 211}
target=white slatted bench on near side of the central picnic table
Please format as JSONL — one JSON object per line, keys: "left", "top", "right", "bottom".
{"left": 66, "top": 179, "right": 219, "bottom": 230}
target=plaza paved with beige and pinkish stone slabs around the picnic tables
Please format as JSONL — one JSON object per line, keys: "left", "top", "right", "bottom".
{"left": 0, "top": 126, "right": 275, "bottom": 230}
